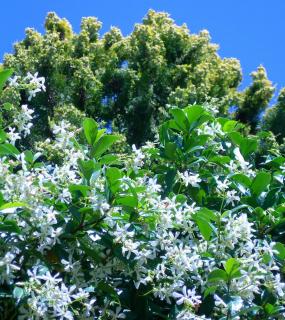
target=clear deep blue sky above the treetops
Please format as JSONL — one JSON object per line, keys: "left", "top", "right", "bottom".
{"left": 0, "top": 0, "right": 285, "bottom": 95}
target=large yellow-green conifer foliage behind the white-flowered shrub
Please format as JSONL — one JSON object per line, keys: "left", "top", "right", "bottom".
{"left": 2, "top": 10, "right": 273, "bottom": 145}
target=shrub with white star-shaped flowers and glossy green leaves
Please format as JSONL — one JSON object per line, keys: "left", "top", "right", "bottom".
{"left": 0, "top": 68, "right": 285, "bottom": 320}
